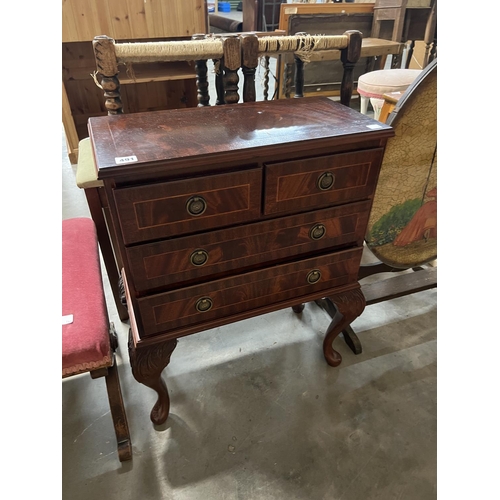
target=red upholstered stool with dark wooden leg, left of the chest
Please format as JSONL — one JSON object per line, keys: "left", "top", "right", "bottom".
{"left": 62, "top": 218, "right": 132, "bottom": 462}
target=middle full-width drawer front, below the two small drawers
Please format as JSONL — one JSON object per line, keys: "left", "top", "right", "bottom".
{"left": 127, "top": 201, "right": 371, "bottom": 292}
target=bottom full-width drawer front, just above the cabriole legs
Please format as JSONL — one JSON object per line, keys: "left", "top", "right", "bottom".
{"left": 137, "top": 247, "right": 363, "bottom": 337}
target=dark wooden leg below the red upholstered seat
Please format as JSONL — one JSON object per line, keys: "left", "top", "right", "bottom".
{"left": 105, "top": 362, "right": 132, "bottom": 462}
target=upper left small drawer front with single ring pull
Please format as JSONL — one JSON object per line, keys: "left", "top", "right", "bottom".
{"left": 114, "top": 169, "right": 262, "bottom": 245}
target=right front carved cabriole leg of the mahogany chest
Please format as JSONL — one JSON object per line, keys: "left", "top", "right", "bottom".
{"left": 323, "top": 285, "right": 366, "bottom": 366}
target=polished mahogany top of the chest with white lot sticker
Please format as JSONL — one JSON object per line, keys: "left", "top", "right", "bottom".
{"left": 88, "top": 97, "right": 394, "bottom": 179}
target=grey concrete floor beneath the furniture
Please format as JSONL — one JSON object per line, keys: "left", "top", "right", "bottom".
{"left": 62, "top": 24, "right": 437, "bottom": 500}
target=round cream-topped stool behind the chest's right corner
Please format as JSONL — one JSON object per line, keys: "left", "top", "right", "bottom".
{"left": 358, "top": 69, "right": 422, "bottom": 120}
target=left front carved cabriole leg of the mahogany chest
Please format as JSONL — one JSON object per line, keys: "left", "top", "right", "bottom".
{"left": 128, "top": 331, "right": 177, "bottom": 425}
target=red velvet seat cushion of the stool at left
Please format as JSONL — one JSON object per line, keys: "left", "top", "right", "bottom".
{"left": 62, "top": 218, "right": 112, "bottom": 378}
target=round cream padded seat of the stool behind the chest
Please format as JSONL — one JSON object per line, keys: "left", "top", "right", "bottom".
{"left": 358, "top": 69, "right": 422, "bottom": 99}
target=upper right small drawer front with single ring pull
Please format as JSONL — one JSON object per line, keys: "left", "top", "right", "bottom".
{"left": 264, "top": 148, "right": 383, "bottom": 214}
